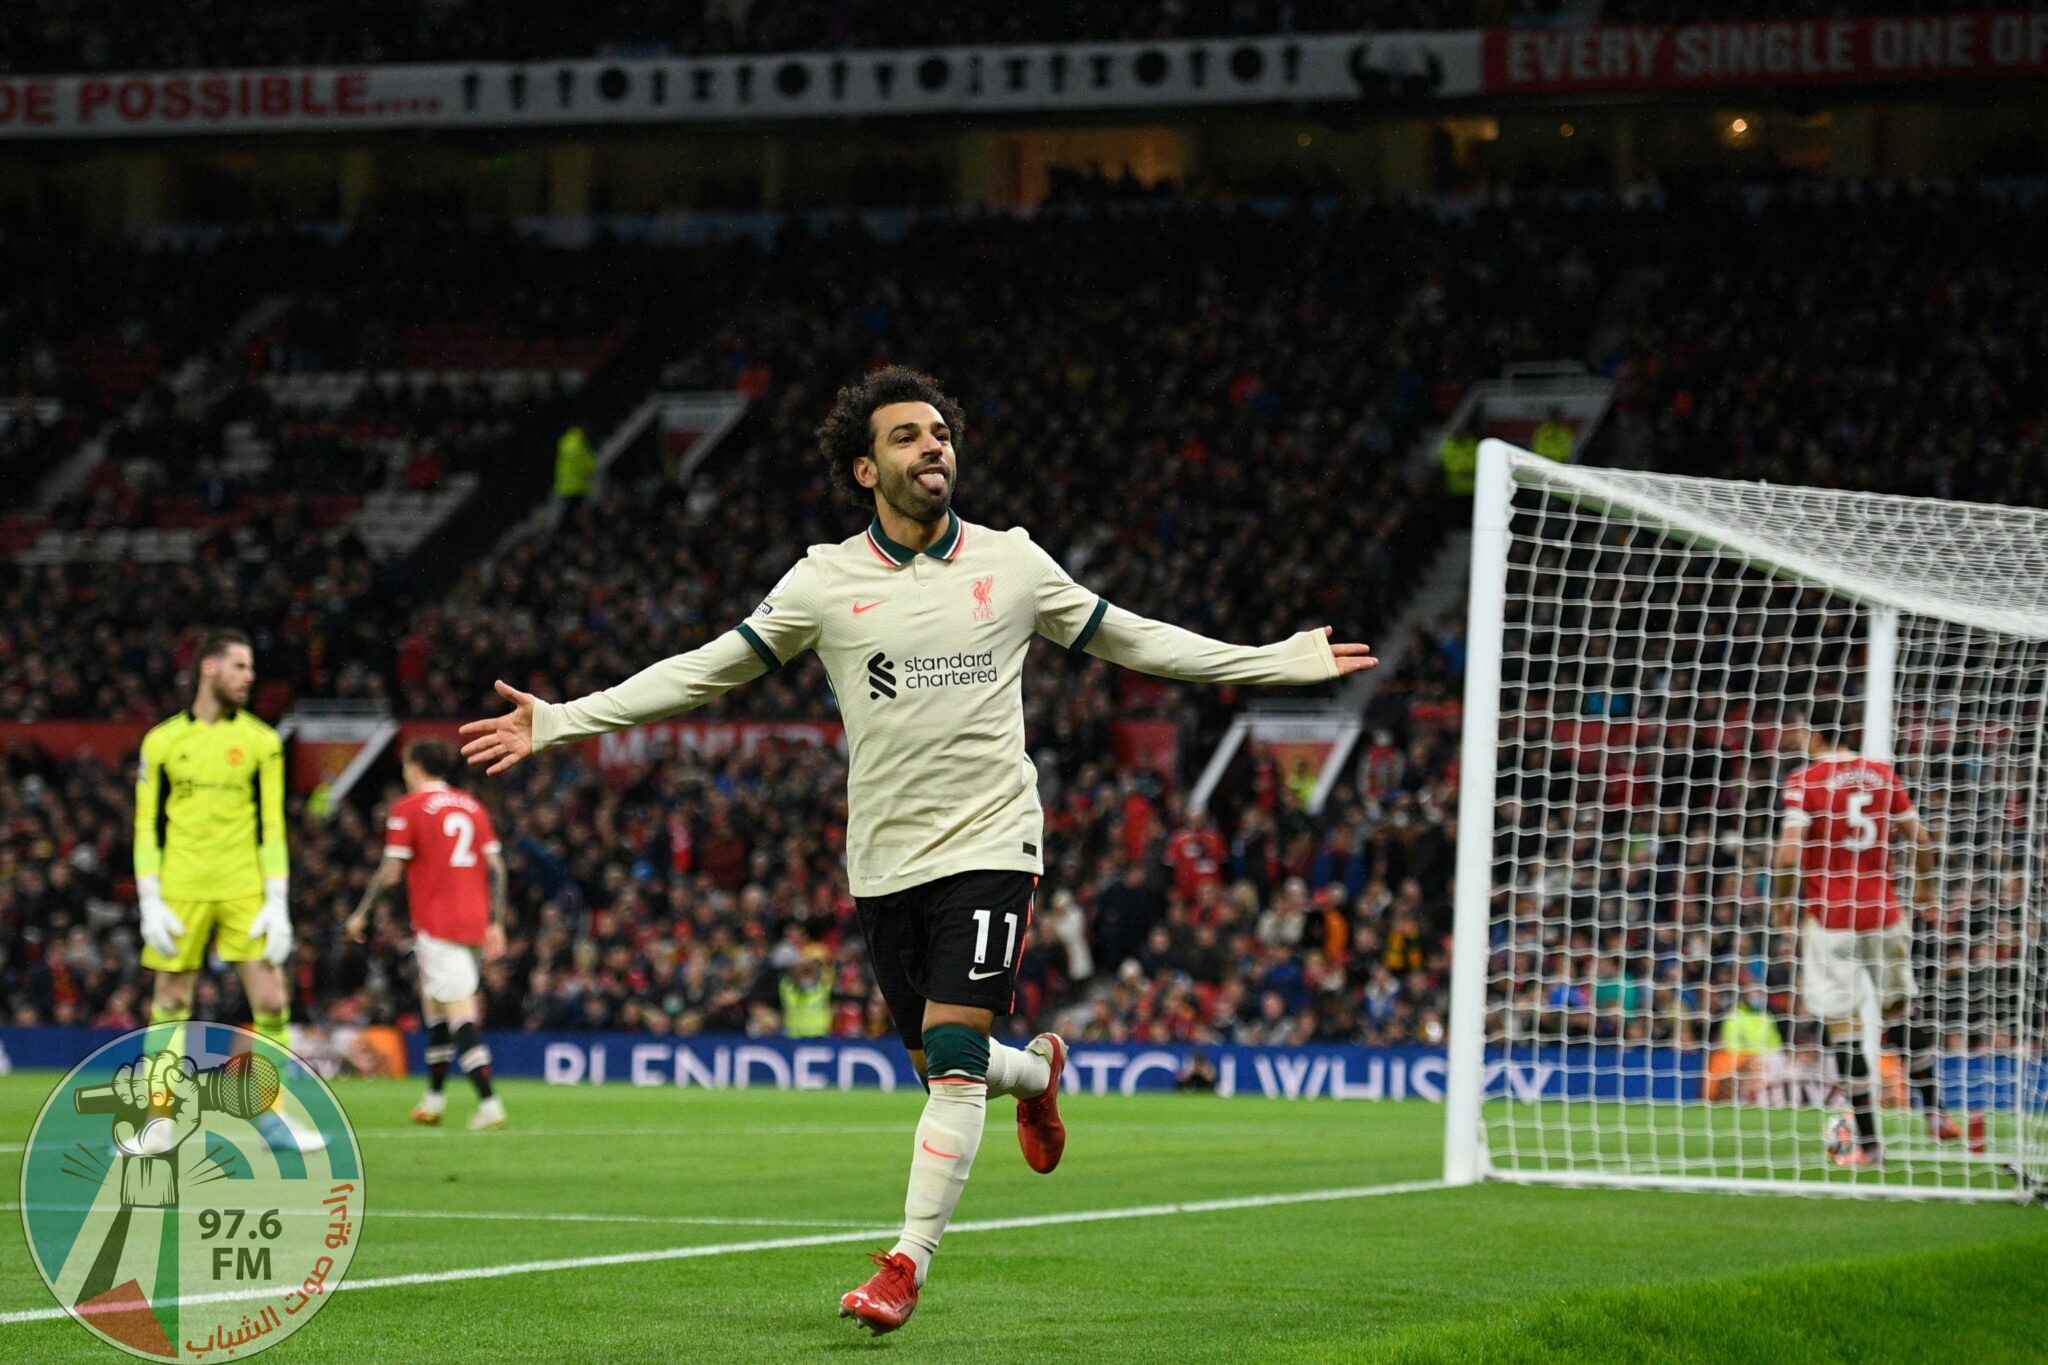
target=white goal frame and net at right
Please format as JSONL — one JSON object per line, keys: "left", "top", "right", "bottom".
{"left": 1446, "top": 442, "right": 2048, "bottom": 1199}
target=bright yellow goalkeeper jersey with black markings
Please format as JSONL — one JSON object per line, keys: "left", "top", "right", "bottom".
{"left": 135, "top": 710, "right": 289, "bottom": 907}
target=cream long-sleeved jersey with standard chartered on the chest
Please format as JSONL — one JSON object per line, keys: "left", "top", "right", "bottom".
{"left": 532, "top": 514, "right": 1337, "bottom": 896}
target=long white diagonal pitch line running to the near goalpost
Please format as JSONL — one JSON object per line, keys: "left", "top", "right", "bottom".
{"left": 0, "top": 1181, "right": 1448, "bottom": 1326}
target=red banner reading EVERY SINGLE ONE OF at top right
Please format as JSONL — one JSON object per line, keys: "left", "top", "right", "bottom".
{"left": 1485, "top": 12, "right": 2048, "bottom": 94}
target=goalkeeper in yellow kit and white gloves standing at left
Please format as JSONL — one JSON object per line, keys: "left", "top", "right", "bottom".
{"left": 135, "top": 630, "right": 317, "bottom": 1146}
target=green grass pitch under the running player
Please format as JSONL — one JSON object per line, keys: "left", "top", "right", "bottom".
{"left": 0, "top": 1074, "right": 2048, "bottom": 1365}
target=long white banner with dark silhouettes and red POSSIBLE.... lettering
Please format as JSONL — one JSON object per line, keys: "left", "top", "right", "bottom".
{"left": 0, "top": 29, "right": 1481, "bottom": 137}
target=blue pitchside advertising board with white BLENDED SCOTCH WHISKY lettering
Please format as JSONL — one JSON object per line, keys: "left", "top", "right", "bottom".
{"left": 0, "top": 1023, "right": 2048, "bottom": 1109}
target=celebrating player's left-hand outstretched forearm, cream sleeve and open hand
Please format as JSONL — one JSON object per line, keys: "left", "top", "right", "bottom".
{"left": 461, "top": 626, "right": 772, "bottom": 776}
